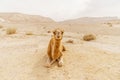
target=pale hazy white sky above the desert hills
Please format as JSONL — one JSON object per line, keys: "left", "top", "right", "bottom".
{"left": 0, "top": 0, "right": 120, "bottom": 21}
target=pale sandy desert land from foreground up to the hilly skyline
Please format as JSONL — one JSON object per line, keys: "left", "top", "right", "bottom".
{"left": 0, "top": 13, "right": 120, "bottom": 80}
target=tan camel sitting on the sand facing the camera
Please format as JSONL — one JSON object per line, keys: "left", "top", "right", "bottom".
{"left": 46, "top": 29, "right": 66, "bottom": 67}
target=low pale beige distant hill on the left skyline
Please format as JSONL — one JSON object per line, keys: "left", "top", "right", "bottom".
{"left": 0, "top": 13, "right": 54, "bottom": 23}
